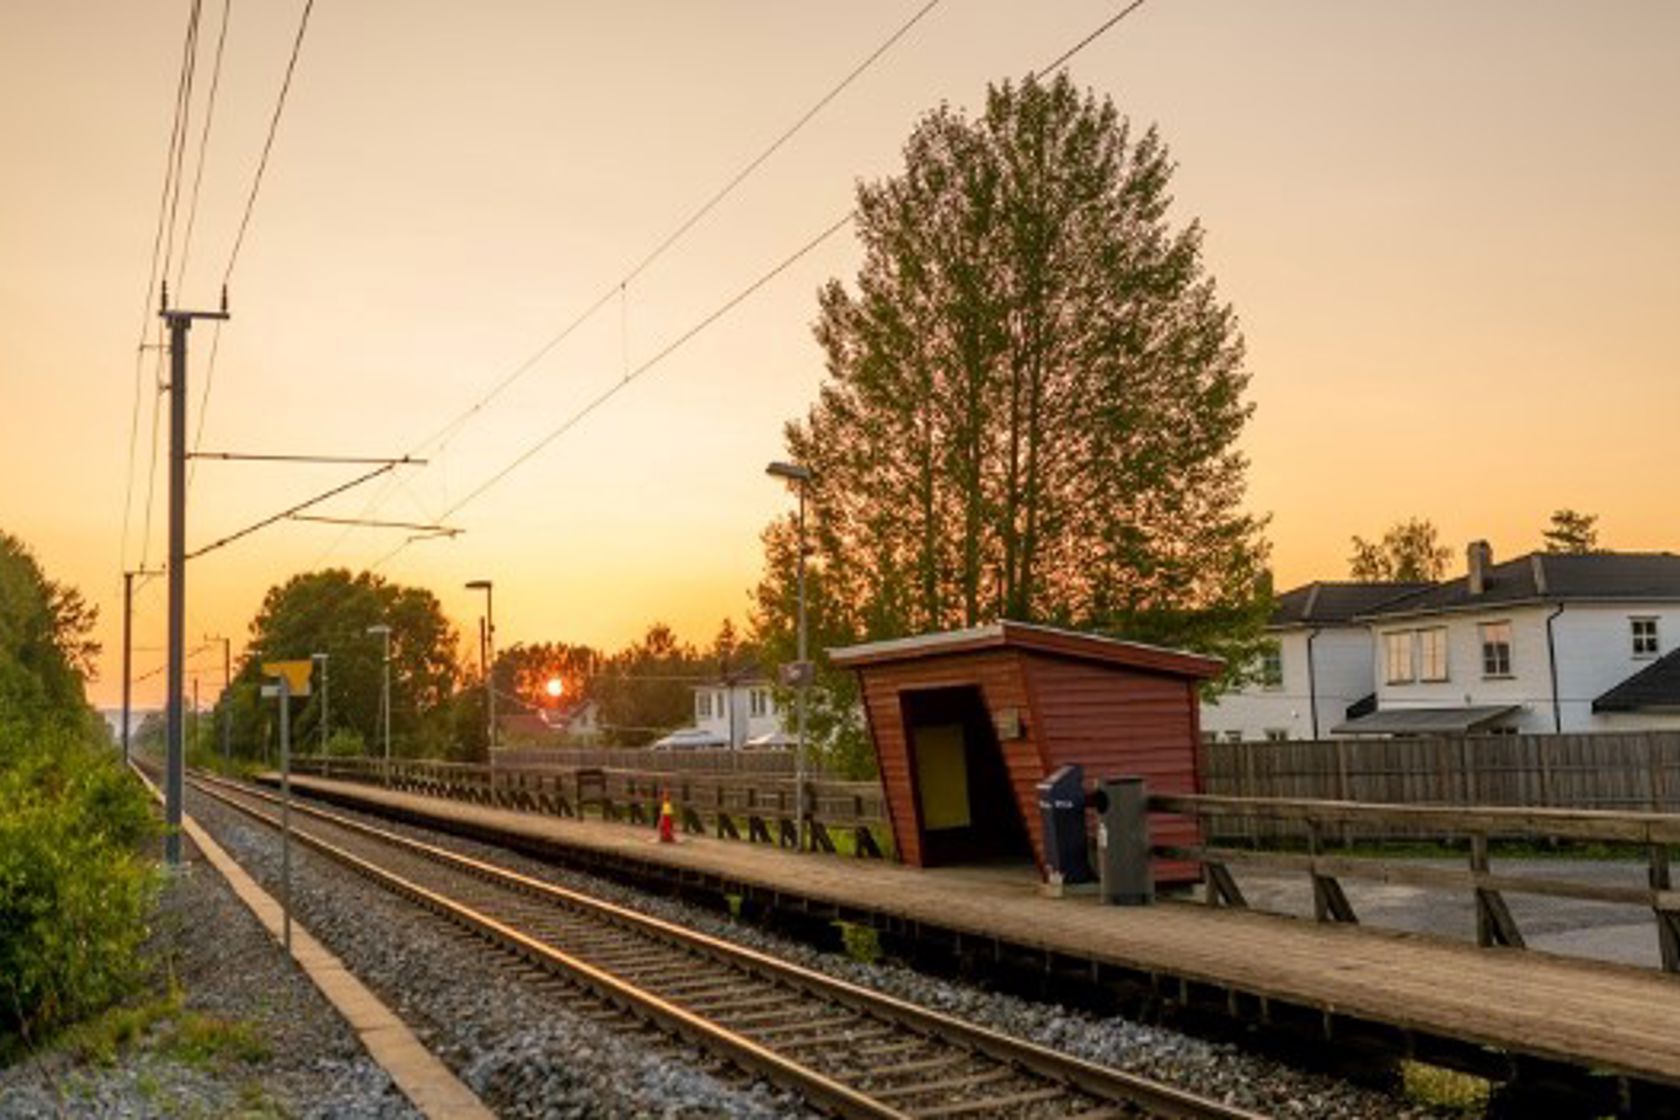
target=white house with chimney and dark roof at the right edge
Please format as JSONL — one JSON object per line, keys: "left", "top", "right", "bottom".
{"left": 1329, "top": 541, "right": 1680, "bottom": 735}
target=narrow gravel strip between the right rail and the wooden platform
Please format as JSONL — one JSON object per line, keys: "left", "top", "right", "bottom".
{"left": 292, "top": 789, "right": 1462, "bottom": 1120}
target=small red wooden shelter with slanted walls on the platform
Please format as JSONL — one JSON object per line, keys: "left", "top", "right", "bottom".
{"left": 828, "top": 621, "right": 1221, "bottom": 883}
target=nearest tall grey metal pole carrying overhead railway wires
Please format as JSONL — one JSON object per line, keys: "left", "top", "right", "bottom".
{"left": 158, "top": 284, "right": 227, "bottom": 868}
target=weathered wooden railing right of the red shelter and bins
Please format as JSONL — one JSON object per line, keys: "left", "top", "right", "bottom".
{"left": 1149, "top": 794, "right": 1680, "bottom": 972}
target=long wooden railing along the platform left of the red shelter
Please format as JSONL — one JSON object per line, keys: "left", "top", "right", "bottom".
{"left": 292, "top": 756, "right": 889, "bottom": 860}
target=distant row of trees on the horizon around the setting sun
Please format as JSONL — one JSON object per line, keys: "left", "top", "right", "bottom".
{"left": 201, "top": 569, "right": 756, "bottom": 761}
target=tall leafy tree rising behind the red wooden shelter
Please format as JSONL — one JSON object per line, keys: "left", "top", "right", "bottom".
{"left": 756, "top": 76, "right": 1267, "bottom": 772}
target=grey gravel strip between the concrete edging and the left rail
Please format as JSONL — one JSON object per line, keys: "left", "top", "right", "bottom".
{"left": 186, "top": 791, "right": 805, "bottom": 1120}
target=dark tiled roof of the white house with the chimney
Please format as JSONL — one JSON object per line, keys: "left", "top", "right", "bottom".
{"left": 1359, "top": 552, "right": 1680, "bottom": 620}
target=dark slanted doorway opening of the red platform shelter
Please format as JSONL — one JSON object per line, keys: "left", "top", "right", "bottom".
{"left": 899, "top": 685, "right": 1033, "bottom": 866}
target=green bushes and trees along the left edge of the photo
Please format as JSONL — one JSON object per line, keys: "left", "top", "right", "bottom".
{"left": 0, "top": 532, "right": 156, "bottom": 1061}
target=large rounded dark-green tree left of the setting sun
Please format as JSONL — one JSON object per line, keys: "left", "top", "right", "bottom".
{"left": 223, "top": 568, "right": 460, "bottom": 757}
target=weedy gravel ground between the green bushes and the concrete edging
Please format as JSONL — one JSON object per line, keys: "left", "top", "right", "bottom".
{"left": 0, "top": 829, "right": 409, "bottom": 1120}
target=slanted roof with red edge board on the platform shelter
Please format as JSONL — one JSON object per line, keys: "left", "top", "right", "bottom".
{"left": 828, "top": 620, "right": 1225, "bottom": 680}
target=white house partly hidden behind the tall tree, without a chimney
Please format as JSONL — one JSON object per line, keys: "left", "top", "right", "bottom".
{"left": 1201, "top": 581, "right": 1433, "bottom": 742}
